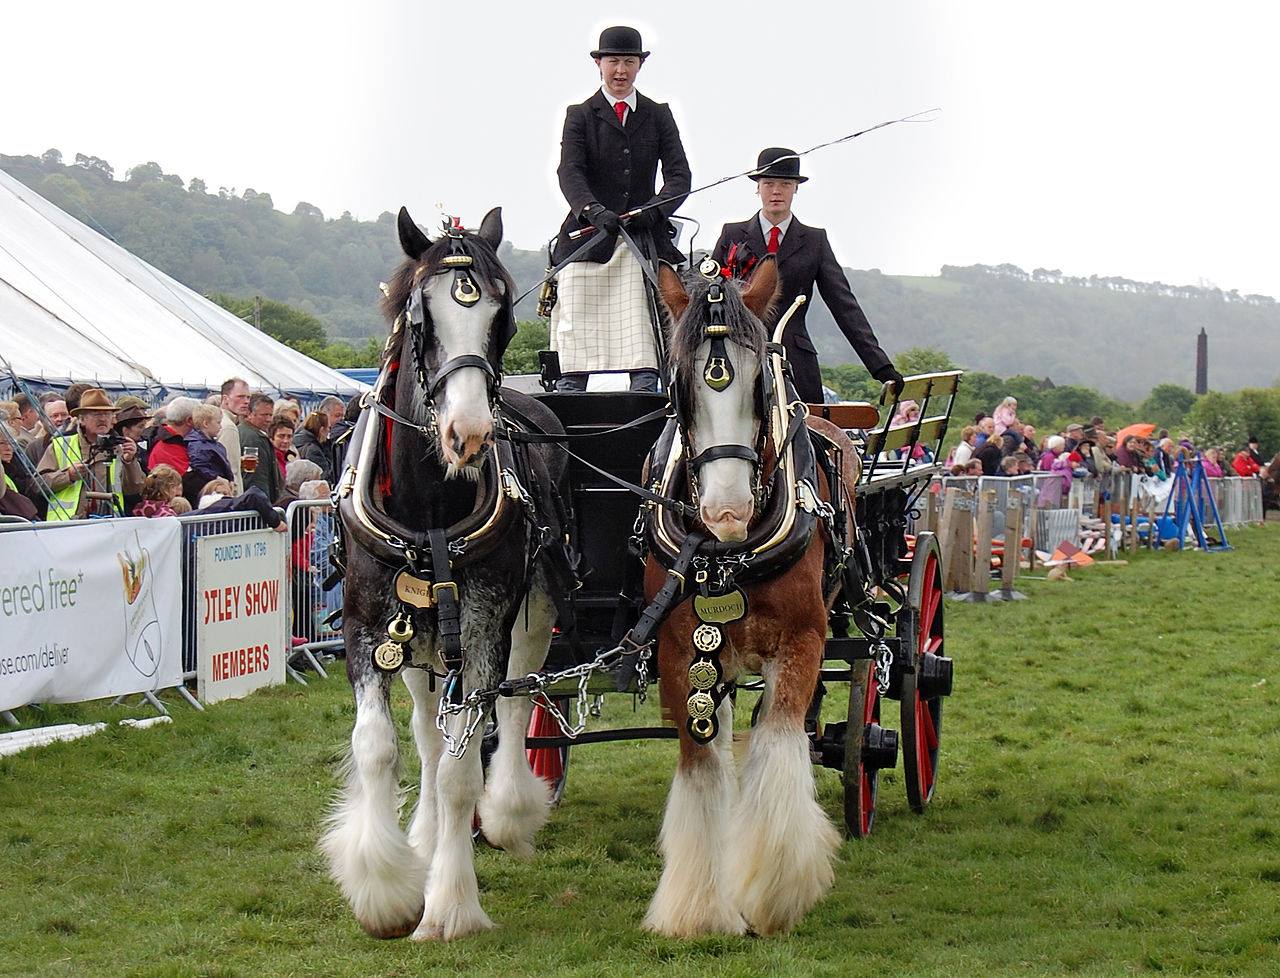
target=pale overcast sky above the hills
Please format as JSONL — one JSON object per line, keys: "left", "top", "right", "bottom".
{"left": 10, "top": 0, "right": 1280, "bottom": 296}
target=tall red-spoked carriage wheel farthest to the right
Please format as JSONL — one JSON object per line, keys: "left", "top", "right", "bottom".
{"left": 895, "top": 534, "right": 951, "bottom": 812}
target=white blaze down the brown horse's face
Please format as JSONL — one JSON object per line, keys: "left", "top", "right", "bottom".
{"left": 690, "top": 342, "right": 760, "bottom": 541}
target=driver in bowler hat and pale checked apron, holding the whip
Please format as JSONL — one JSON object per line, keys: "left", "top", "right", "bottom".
{"left": 550, "top": 27, "right": 691, "bottom": 390}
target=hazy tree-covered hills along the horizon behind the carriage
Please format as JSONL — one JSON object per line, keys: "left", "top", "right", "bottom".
{"left": 0, "top": 150, "right": 1280, "bottom": 401}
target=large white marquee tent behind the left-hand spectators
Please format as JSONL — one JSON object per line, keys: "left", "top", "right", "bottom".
{"left": 0, "top": 170, "right": 366, "bottom": 399}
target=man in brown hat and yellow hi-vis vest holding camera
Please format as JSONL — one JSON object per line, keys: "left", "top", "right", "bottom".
{"left": 38, "top": 387, "right": 145, "bottom": 521}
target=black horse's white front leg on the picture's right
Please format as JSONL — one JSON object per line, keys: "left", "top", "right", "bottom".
{"left": 411, "top": 716, "right": 493, "bottom": 941}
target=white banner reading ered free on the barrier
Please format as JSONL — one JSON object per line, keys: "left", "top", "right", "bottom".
{"left": 0, "top": 517, "right": 182, "bottom": 709}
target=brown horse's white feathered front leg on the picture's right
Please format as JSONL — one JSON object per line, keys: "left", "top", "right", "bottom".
{"left": 730, "top": 716, "right": 840, "bottom": 934}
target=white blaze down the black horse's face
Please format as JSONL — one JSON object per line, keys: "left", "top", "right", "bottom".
{"left": 425, "top": 282, "right": 500, "bottom": 475}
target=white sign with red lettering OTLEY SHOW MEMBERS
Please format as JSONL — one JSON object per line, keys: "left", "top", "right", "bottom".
{"left": 195, "top": 530, "right": 289, "bottom": 703}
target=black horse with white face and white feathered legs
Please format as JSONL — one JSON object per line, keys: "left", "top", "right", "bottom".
{"left": 320, "top": 207, "right": 566, "bottom": 941}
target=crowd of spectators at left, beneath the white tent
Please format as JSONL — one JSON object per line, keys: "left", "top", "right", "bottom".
{"left": 0, "top": 378, "right": 358, "bottom": 531}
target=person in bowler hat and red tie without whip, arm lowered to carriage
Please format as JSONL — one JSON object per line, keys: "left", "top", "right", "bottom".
{"left": 712, "top": 146, "right": 902, "bottom": 403}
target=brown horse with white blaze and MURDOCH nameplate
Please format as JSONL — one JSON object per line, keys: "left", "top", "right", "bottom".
{"left": 645, "top": 260, "right": 856, "bottom": 937}
